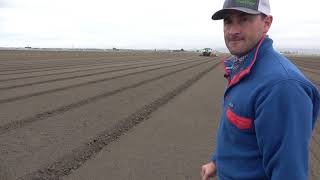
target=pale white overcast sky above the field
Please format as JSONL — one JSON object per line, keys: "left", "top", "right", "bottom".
{"left": 0, "top": 0, "right": 320, "bottom": 49}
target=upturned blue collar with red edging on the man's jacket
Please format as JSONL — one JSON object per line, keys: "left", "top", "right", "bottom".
{"left": 222, "top": 35, "right": 272, "bottom": 87}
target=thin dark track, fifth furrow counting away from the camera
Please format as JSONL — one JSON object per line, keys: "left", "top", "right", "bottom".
{"left": 0, "top": 59, "right": 191, "bottom": 82}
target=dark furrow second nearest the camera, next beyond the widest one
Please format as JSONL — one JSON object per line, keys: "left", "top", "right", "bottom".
{"left": 0, "top": 60, "right": 215, "bottom": 135}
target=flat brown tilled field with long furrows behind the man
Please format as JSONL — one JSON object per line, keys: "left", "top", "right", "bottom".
{"left": 0, "top": 50, "right": 320, "bottom": 180}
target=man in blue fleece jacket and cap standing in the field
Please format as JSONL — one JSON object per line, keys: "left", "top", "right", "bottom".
{"left": 201, "top": 0, "right": 320, "bottom": 180}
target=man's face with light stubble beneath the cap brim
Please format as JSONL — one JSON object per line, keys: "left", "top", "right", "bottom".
{"left": 223, "top": 10, "right": 272, "bottom": 57}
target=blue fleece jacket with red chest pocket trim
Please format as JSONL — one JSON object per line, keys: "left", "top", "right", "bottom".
{"left": 212, "top": 37, "right": 320, "bottom": 180}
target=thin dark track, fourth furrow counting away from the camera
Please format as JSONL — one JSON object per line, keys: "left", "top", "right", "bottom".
{"left": 0, "top": 58, "right": 196, "bottom": 90}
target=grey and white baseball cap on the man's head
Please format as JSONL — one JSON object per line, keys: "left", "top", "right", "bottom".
{"left": 212, "top": 0, "right": 270, "bottom": 20}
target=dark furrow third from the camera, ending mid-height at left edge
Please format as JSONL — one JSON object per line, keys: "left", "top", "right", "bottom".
{"left": 0, "top": 59, "right": 200, "bottom": 104}
